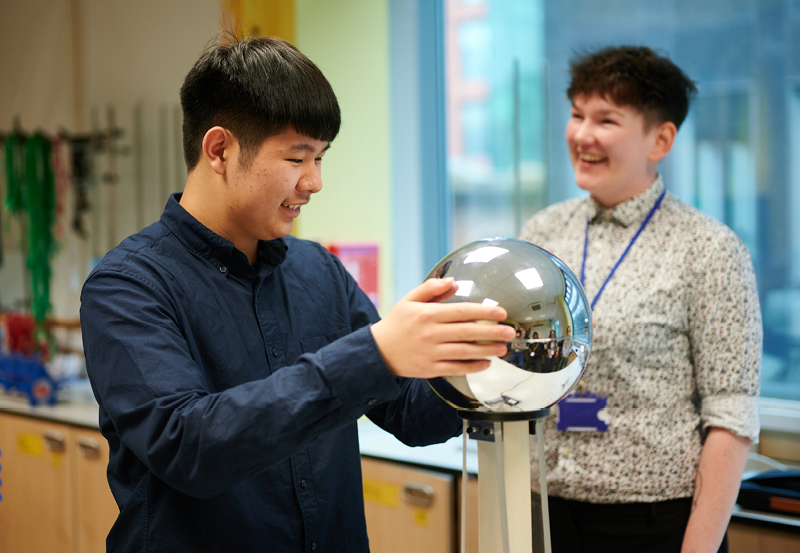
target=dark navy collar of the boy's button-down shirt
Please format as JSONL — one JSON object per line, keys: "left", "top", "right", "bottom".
{"left": 161, "top": 192, "right": 289, "bottom": 272}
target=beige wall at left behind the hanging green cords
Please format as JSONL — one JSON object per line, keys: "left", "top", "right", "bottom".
{"left": 0, "top": 0, "right": 220, "bottom": 317}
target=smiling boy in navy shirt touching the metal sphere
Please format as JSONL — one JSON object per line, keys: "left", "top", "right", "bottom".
{"left": 81, "top": 39, "right": 514, "bottom": 553}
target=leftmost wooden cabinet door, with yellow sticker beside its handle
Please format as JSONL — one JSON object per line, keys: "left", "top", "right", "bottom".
{"left": 0, "top": 415, "right": 74, "bottom": 553}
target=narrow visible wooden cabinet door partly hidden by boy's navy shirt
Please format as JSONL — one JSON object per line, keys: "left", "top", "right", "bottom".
{"left": 73, "top": 428, "right": 119, "bottom": 553}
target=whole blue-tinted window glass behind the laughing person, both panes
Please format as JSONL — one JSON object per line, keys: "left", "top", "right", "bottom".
{"left": 445, "top": 0, "right": 800, "bottom": 400}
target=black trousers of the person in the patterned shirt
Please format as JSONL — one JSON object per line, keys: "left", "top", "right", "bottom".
{"left": 531, "top": 494, "right": 728, "bottom": 553}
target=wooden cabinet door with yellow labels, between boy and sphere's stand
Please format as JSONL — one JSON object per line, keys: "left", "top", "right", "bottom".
{"left": 361, "top": 458, "right": 456, "bottom": 553}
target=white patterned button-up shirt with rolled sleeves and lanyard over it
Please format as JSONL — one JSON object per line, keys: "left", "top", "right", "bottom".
{"left": 520, "top": 177, "right": 762, "bottom": 503}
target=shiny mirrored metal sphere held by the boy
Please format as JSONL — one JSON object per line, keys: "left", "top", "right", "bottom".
{"left": 427, "top": 238, "right": 592, "bottom": 411}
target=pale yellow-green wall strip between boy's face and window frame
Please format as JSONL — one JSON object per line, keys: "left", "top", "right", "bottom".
{"left": 295, "top": 0, "right": 395, "bottom": 313}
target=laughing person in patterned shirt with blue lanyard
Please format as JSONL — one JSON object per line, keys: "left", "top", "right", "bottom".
{"left": 521, "top": 47, "right": 762, "bottom": 552}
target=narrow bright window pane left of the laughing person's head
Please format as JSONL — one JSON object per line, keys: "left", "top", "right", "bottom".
{"left": 445, "top": 0, "right": 545, "bottom": 245}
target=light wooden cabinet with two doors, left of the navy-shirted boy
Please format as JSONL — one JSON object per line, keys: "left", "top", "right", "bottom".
{"left": 0, "top": 414, "right": 118, "bottom": 553}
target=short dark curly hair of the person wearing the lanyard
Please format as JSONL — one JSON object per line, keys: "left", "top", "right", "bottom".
{"left": 567, "top": 46, "right": 697, "bottom": 128}
